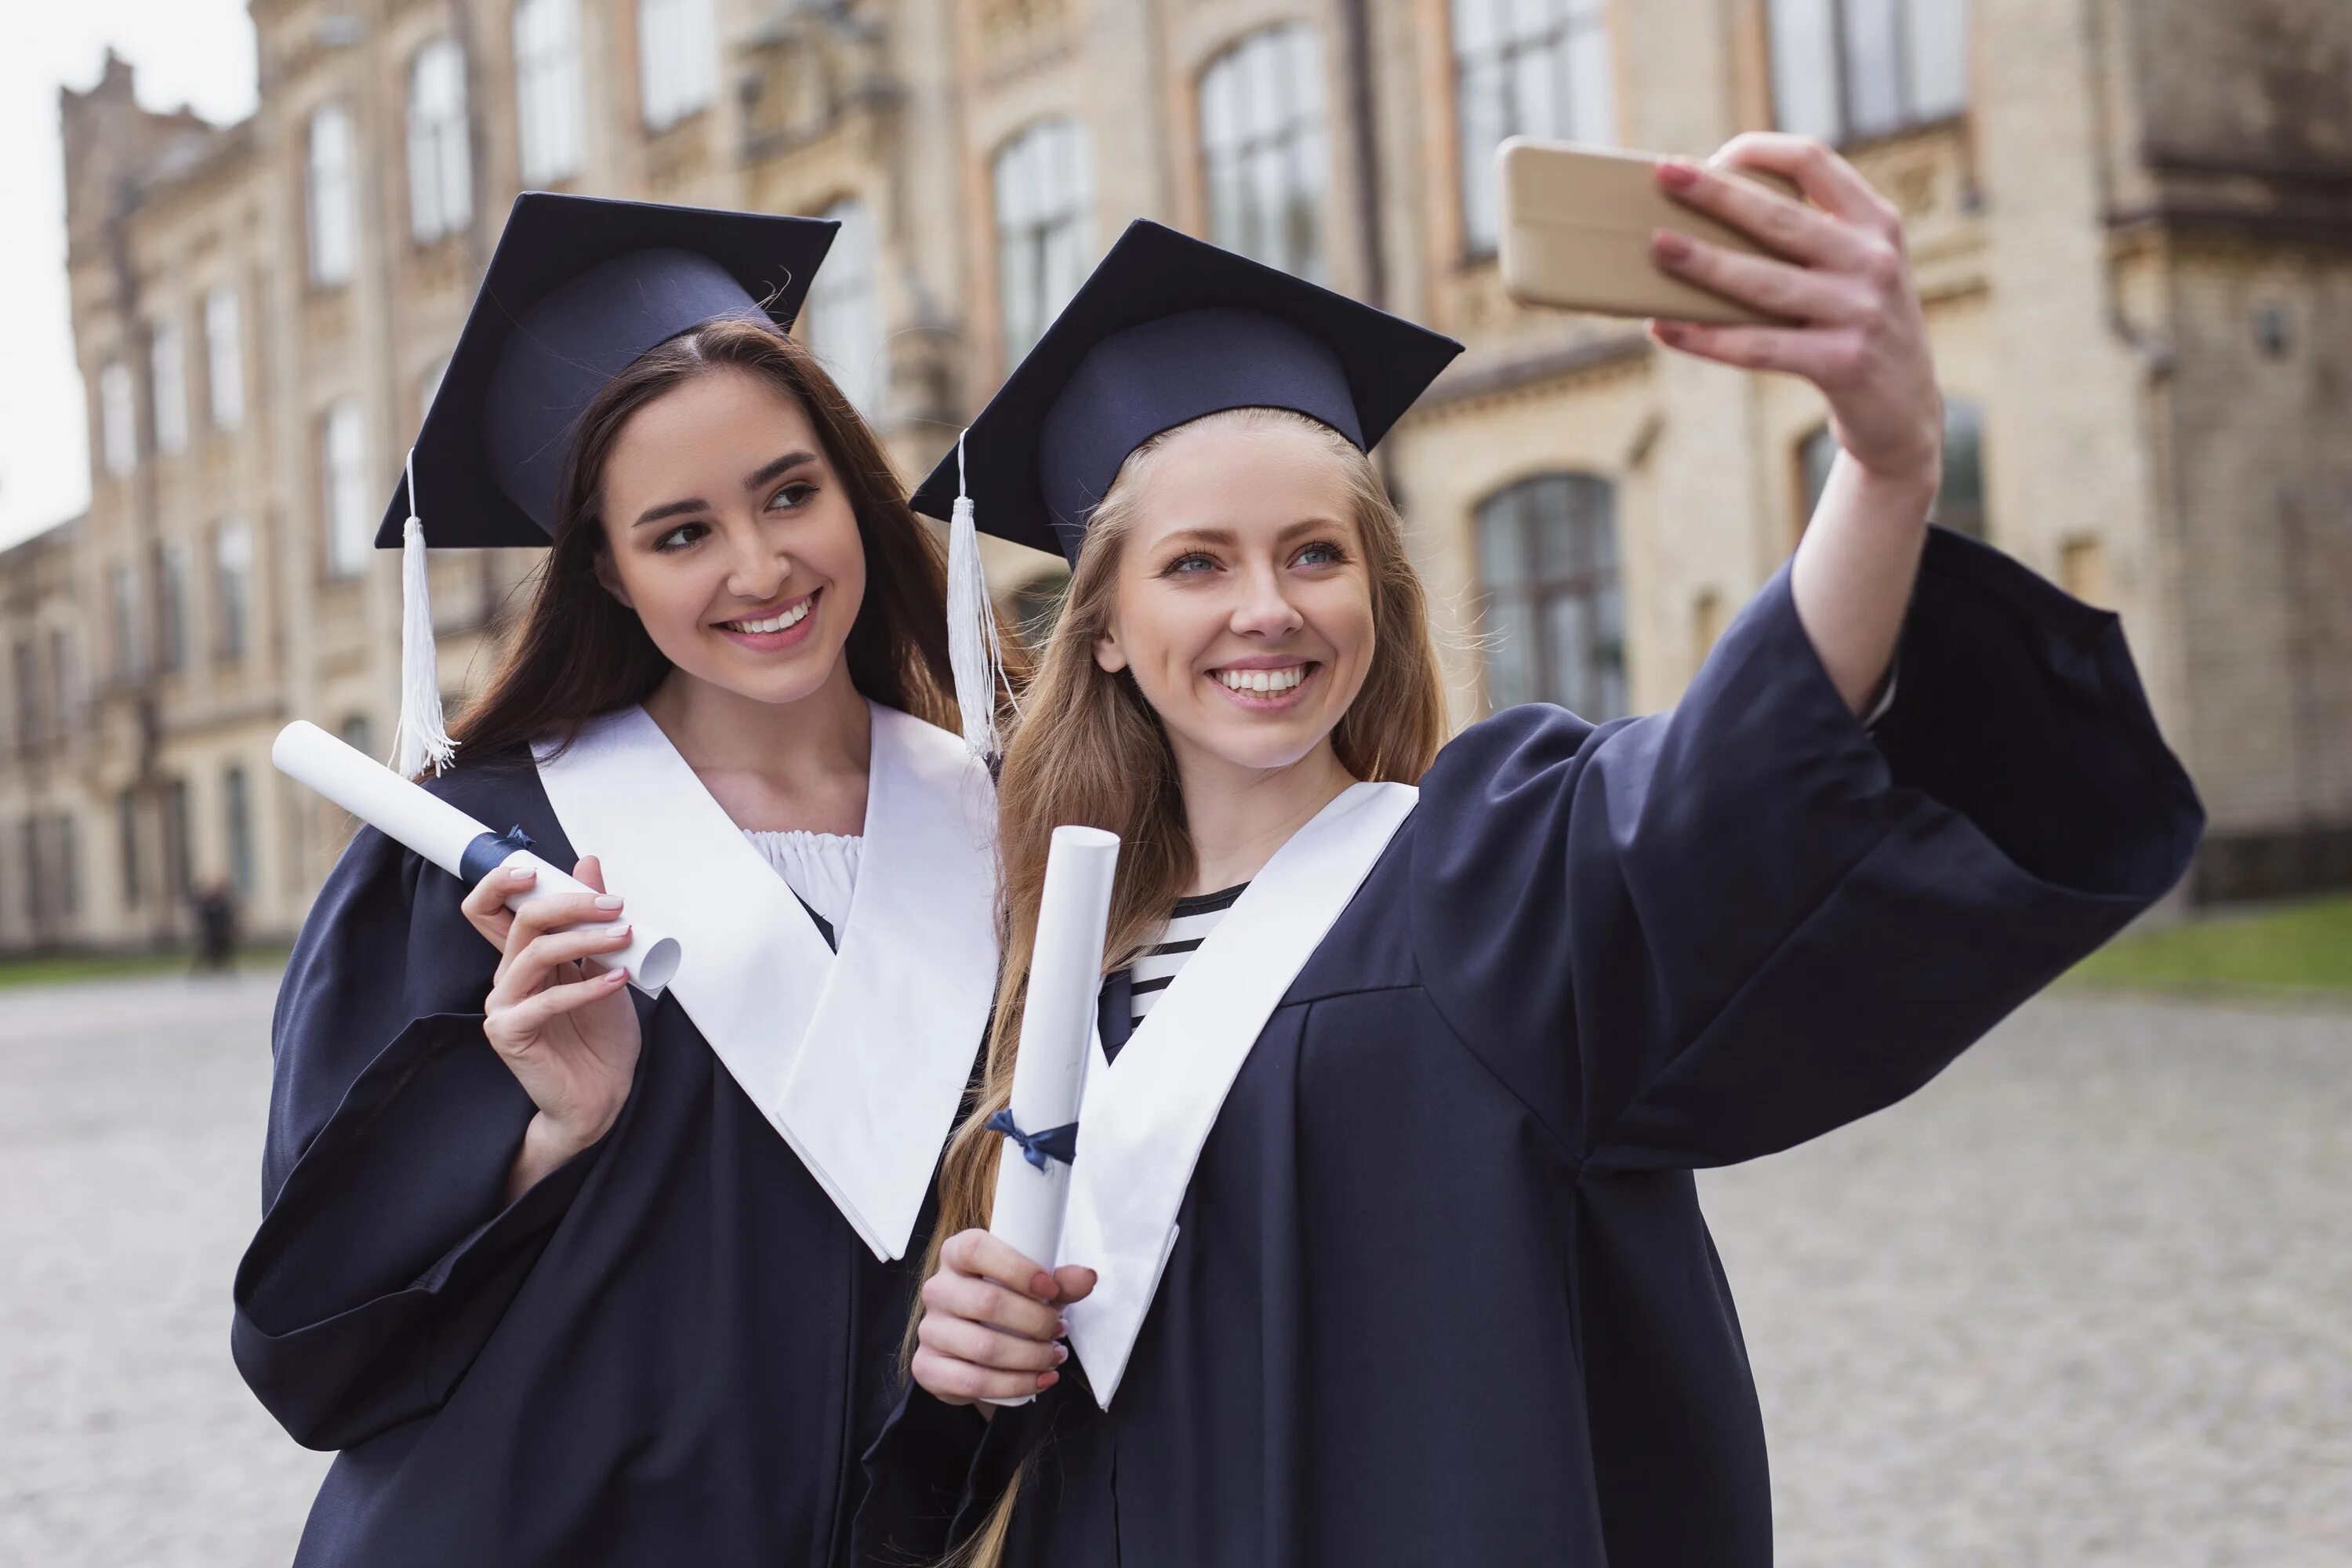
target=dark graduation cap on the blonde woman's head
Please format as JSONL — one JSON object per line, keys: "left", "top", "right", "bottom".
{"left": 913, "top": 219, "right": 1463, "bottom": 562}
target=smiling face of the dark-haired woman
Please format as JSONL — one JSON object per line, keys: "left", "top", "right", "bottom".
{"left": 597, "top": 367, "right": 866, "bottom": 703}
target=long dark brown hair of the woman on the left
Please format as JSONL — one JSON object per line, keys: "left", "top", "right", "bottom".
{"left": 452, "top": 318, "right": 1021, "bottom": 757}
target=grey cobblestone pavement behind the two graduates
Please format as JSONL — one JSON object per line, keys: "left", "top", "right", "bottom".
{"left": 0, "top": 975, "right": 2352, "bottom": 1568}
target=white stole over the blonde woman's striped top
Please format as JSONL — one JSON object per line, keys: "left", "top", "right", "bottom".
{"left": 1056, "top": 783, "right": 1421, "bottom": 1410}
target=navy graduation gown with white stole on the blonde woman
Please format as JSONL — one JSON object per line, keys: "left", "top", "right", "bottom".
{"left": 866, "top": 532, "right": 2201, "bottom": 1568}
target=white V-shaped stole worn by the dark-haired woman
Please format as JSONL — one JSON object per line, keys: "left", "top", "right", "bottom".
{"left": 539, "top": 703, "right": 997, "bottom": 1258}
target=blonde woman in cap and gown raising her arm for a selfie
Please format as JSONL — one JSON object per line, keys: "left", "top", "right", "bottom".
{"left": 866, "top": 136, "right": 2201, "bottom": 1568}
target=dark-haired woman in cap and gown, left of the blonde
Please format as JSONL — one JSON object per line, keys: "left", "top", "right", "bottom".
{"left": 233, "top": 195, "right": 1016, "bottom": 1568}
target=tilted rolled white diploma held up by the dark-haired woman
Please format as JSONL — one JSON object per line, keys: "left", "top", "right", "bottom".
{"left": 270, "top": 720, "right": 680, "bottom": 996}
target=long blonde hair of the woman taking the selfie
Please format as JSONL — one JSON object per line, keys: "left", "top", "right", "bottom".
{"left": 906, "top": 409, "right": 1446, "bottom": 1568}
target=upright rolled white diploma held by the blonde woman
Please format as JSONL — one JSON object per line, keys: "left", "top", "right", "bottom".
{"left": 988, "top": 827, "right": 1120, "bottom": 1406}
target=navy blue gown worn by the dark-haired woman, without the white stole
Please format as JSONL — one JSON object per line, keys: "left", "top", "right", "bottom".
{"left": 233, "top": 757, "right": 931, "bottom": 1568}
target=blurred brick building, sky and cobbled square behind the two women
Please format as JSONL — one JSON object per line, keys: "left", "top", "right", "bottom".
{"left": 0, "top": 0, "right": 2352, "bottom": 1563}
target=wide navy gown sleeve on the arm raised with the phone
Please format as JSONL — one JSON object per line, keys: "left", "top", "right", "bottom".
{"left": 1414, "top": 529, "right": 2204, "bottom": 1168}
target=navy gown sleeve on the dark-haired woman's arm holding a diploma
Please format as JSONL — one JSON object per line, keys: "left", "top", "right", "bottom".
{"left": 230, "top": 776, "right": 595, "bottom": 1448}
